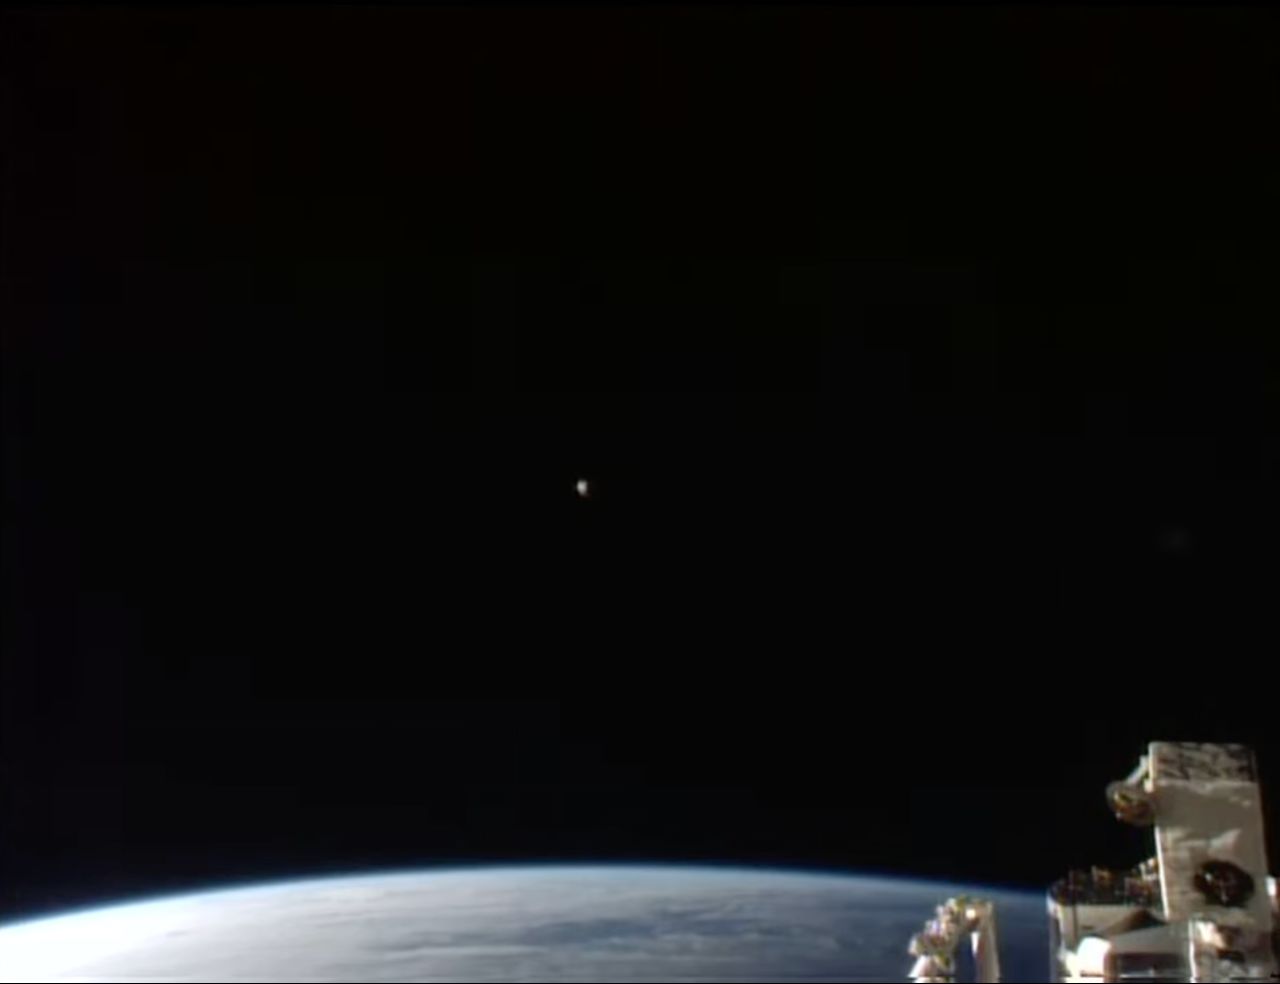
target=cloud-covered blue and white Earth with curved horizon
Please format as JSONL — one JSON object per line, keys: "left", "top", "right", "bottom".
{"left": 0, "top": 862, "right": 1047, "bottom": 981}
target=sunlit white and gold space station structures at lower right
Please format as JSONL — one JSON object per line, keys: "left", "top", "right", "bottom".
{"left": 909, "top": 741, "right": 1280, "bottom": 981}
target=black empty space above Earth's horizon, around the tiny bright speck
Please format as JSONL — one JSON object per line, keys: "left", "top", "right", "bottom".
{"left": 0, "top": 5, "right": 1280, "bottom": 917}
